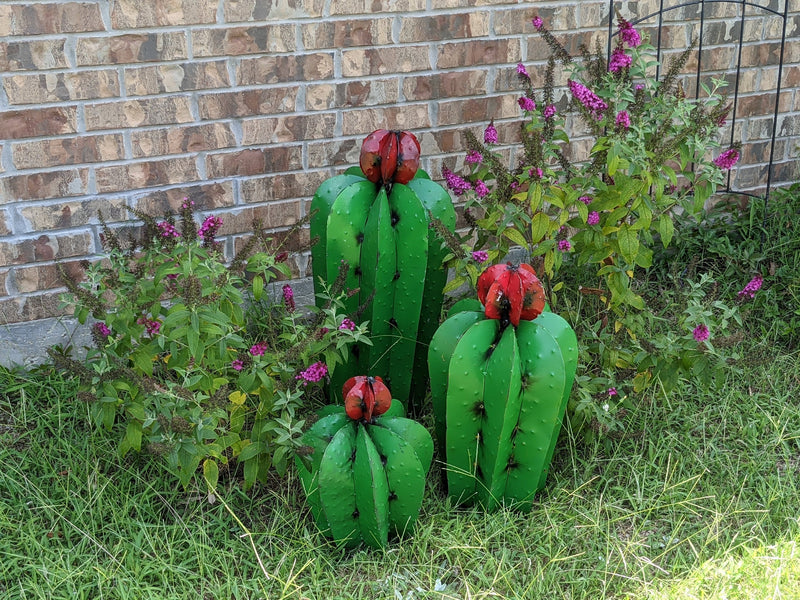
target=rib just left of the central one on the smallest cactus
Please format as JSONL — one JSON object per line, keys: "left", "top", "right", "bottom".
{"left": 319, "top": 423, "right": 361, "bottom": 547}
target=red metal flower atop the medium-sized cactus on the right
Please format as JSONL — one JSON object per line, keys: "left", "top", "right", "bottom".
{"left": 478, "top": 263, "right": 545, "bottom": 327}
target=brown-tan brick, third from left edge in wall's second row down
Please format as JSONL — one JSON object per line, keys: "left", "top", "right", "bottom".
{"left": 192, "top": 25, "right": 297, "bottom": 58}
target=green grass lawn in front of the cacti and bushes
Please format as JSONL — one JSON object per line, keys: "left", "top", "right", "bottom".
{"left": 0, "top": 345, "right": 800, "bottom": 600}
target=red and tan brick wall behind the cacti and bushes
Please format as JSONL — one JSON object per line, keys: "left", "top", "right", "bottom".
{"left": 0, "top": 0, "right": 800, "bottom": 326}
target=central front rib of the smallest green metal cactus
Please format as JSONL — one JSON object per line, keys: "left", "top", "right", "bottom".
{"left": 353, "top": 424, "right": 389, "bottom": 548}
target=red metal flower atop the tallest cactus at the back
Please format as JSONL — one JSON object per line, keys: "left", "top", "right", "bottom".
{"left": 359, "top": 129, "right": 420, "bottom": 185}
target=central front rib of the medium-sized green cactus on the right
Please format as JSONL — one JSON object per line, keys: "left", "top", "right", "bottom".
{"left": 478, "top": 327, "right": 522, "bottom": 511}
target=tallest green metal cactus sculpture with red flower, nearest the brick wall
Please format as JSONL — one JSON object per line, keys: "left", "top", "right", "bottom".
{"left": 311, "top": 129, "right": 455, "bottom": 401}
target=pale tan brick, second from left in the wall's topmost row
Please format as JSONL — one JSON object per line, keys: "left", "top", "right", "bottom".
{"left": 111, "top": 0, "right": 217, "bottom": 29}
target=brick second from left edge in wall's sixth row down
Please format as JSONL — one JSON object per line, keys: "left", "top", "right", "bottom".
{"left": 95, "top": 158, "right": 199, "bottom": 193}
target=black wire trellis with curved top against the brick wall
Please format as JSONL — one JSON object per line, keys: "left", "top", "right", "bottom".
{"left": 608, "top": 0, "right": 789, "bottom": 209}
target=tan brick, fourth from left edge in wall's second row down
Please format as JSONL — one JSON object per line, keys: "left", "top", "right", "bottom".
{"left": 301, "top": 17, "right": 394, "bottom": 50}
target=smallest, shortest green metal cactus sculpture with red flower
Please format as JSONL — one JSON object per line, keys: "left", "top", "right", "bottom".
{"left": 296, "top": 376, "right": 433, "bottom": 548}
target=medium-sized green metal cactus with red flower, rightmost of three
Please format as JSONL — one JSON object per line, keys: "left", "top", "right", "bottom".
{"left": 428, "top": 264, "right": 578, "bottom": 510}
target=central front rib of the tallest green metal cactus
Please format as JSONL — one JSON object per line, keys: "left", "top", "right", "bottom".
{"left": 359, "top": 188, "right": 397, "bottom": 378}
